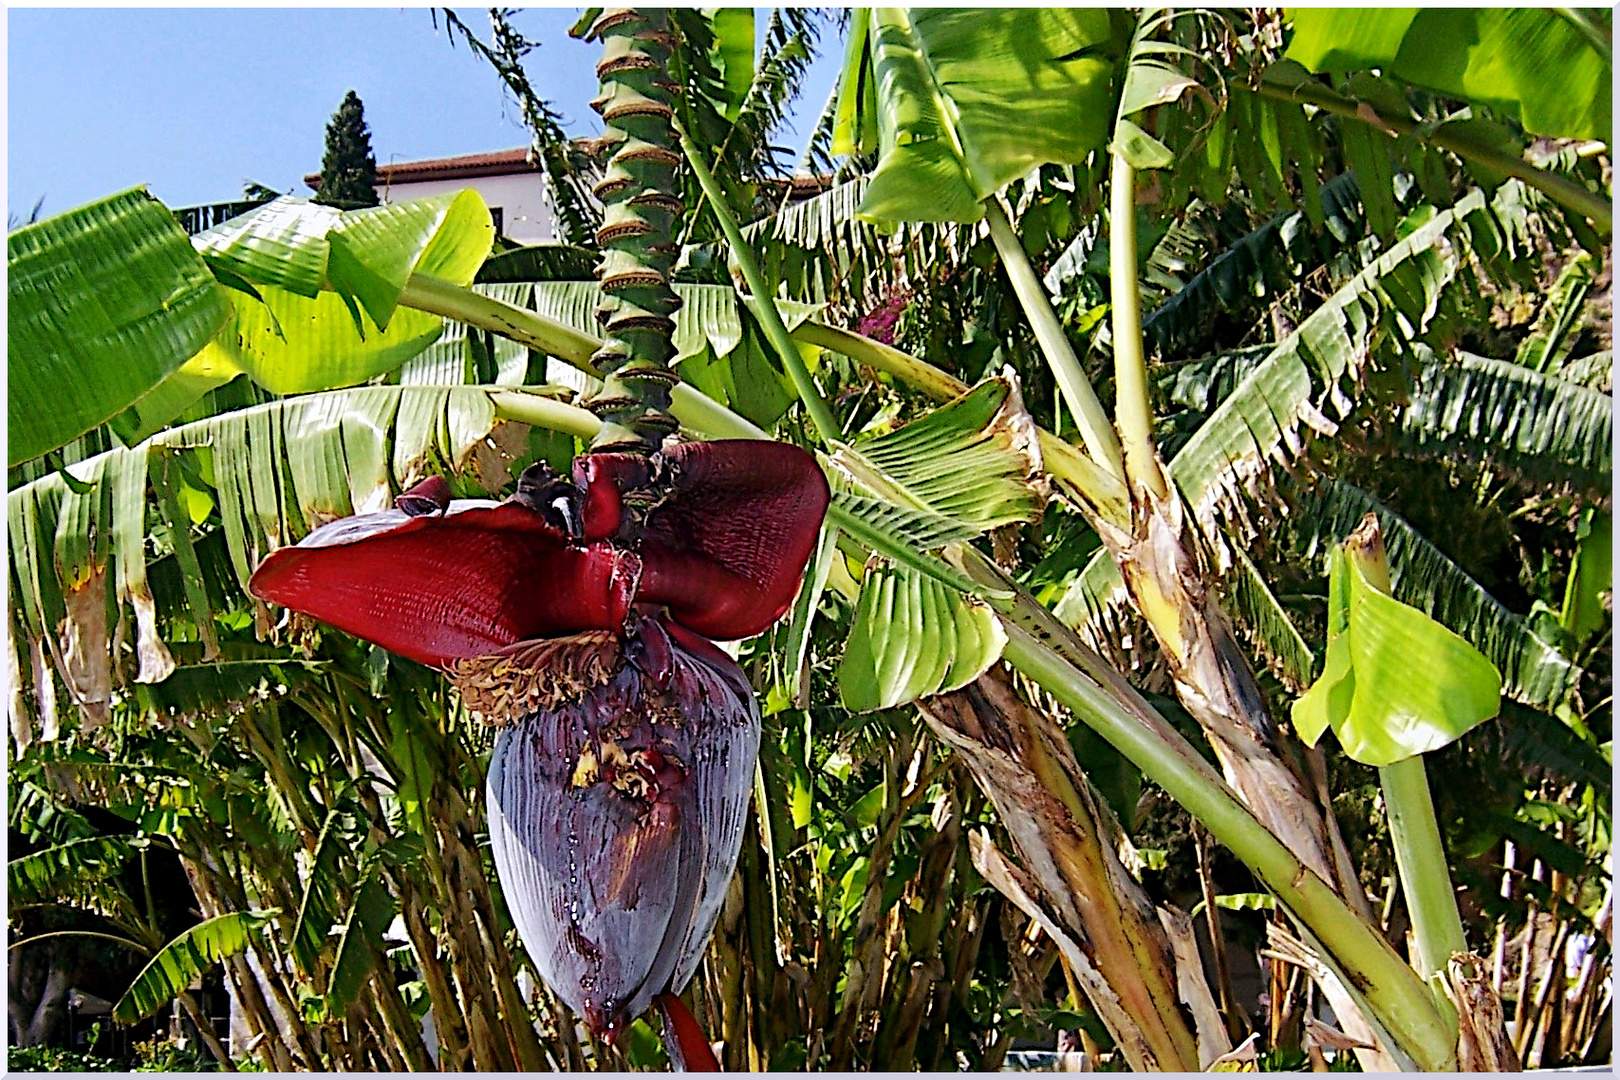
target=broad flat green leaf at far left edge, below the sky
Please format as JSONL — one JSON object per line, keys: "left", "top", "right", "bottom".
{"left": 6, "top": 189, "right": 230, "bottom": 465}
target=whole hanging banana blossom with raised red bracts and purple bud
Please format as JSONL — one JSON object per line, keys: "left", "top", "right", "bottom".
{"left": 249, "top": 442, "right": 828, "bottom": 1069}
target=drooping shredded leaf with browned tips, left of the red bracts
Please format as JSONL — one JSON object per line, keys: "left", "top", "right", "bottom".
{"left": 8, "top": 387, "right": 537, "bottom": 748}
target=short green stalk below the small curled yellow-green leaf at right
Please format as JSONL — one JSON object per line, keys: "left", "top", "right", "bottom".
{"left": 1379, "top": 755, "right": 1468, "bottom": 978}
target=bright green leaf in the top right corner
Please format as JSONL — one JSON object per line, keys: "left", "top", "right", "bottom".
{"left": 1286, "top": 6, "right": 1614, "bottom": 142}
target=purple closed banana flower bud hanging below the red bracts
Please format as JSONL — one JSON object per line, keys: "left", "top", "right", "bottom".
{"left": 479, "top": 620, "right": 760, "bottom": 1049}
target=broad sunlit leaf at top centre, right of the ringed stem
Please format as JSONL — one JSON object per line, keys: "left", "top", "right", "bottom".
{"left": 838, "top": 6, "right": 1128, "bottom": 222}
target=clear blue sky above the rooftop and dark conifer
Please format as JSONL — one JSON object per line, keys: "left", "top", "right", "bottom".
{"left": 6, "top": 8, "right": 842, "bottom": 226}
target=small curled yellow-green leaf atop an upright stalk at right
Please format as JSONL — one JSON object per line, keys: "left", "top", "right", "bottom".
{"left": 1293, "top": 537, "right": 1502, "bottom": 767}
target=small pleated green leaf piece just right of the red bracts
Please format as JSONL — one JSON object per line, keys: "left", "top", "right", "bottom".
{"left": 838, "top": 567, "right": 1006, "bottom": 712}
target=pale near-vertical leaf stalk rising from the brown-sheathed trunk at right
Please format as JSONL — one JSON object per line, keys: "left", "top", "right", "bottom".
{"left": 1108, "top": 154, "right": 1170, "bottom": 500}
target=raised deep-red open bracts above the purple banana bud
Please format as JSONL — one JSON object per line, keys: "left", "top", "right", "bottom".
{"left": 249, "top": 440, "right": 828, "bottom": 667}
